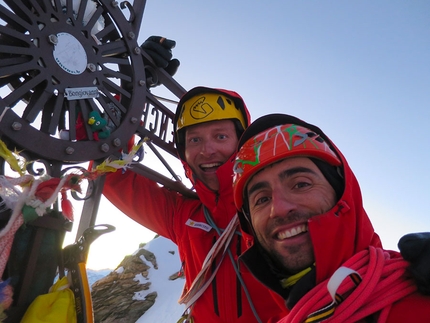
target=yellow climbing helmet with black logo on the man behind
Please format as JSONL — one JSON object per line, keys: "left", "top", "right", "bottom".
{"left": 177, "top": 93, "right": 246, "bottom": 130}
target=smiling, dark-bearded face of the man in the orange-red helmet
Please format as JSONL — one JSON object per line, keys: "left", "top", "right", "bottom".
{"left": 246, "top": 157, "right": 336, "bottom": 274}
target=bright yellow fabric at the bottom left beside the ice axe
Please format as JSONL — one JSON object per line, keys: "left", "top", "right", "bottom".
{"left": 21, "top": 277, "right": 76, "bottom": 323}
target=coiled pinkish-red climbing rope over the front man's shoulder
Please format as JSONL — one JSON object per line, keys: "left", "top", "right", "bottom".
{"left": 279, "top": 246, "right": 416, "bottom": 323}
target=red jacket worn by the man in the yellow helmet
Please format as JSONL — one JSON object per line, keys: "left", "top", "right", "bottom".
{"left": 103, "top": 88, "right": 287, "bottom": 323}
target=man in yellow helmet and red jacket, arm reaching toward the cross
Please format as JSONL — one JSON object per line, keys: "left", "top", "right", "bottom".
{"left": 103, "top": 87, "right": 287, "bottom": 323}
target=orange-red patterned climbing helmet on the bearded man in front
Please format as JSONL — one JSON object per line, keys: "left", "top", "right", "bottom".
{"left": 233, "top": 114, "right": 342, "bottom": 210}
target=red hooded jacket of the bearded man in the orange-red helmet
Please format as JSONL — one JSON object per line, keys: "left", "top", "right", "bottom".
{"left": 239, "top": 117, "right": 430, "bottom": 323}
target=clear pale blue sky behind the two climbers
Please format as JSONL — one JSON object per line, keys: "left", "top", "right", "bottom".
{"left": 66, "top": 0, "right": 430, "bottom": 268}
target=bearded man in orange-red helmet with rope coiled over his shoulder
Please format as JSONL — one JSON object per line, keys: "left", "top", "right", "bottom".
{"left": 233, "top": 114, "right": 430, "bottom": 323}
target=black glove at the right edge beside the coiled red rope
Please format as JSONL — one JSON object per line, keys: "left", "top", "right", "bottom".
{"left": 398, "top": 232, "right": 430, "bottom": 295}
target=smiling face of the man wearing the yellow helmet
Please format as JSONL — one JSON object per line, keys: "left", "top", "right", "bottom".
{"left": 185, "top": 120, "right": 238, "bottom": 191}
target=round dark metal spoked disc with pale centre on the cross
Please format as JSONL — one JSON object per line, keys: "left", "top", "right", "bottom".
{"left": 0, "top": 0, "right": 146, "bottom": 162}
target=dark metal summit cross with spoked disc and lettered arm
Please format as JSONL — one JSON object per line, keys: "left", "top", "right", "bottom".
{"left": 0, "top": 0, "right": 194, "bottom": 322}
